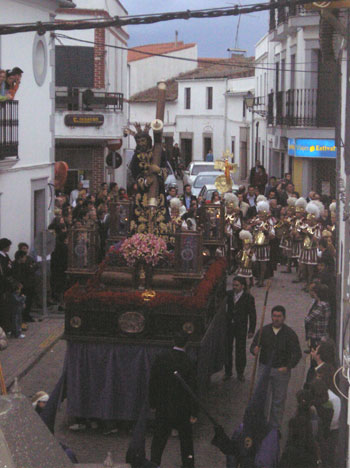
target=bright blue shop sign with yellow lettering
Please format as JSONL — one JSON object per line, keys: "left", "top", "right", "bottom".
{"left": 288, "top": 138, "right": 337, "bottom": 158}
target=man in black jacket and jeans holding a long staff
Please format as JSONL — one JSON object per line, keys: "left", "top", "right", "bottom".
{"left": 250, "top": 305, "right": 301, "bottom": 429}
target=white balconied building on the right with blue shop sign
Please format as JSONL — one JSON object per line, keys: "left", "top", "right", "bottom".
{"left": 254, "top": 6, "right": 337, "bottom": 196}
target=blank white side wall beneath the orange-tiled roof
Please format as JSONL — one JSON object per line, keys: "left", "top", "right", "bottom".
{"left": 129, "top": 45, "right": 198, "bottom": 96}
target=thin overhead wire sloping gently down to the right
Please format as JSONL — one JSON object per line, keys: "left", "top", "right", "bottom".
{"left": 55, "top": 33, "right": 330, "bottom": 74}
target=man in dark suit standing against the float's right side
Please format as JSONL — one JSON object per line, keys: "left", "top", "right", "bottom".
{"left": 225, "top": 276, "right": 256, "bottom": 382}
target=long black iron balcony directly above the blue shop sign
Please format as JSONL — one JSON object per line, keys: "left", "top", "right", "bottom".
{"left": 267, "top": 89, "right": 336, "bottom": 127}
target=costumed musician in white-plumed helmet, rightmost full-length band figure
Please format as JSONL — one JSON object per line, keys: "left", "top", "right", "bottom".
{"left": 299, "top": 201, "right": 322, "bottom": 291}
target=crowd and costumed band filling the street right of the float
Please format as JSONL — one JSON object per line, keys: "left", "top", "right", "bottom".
{"left": 162, "top": 161, "right": 340, "bottom": 468}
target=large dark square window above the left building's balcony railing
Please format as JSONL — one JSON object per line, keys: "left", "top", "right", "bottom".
{"left": 55, "top": 46, "right": 94, "bottom": 88}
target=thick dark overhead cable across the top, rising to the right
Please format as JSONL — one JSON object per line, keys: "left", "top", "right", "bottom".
{"left": 0, "top": 0, "right": 322, "bottom": 35}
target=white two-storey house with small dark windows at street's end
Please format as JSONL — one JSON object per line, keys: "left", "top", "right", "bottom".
{"left": 130, "top": 66, "right": 254, "bottom": 180}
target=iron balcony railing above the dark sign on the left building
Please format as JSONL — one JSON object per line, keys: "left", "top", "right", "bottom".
{"left": 55, "top": 88, "right": 124, "bottom": 112}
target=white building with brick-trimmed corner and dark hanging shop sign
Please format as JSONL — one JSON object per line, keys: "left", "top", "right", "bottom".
{"left": 55, "top": 0, "right": 129, "bottom": 192}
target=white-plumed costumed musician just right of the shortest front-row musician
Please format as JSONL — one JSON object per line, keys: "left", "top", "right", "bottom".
{"left": 251, "top": 201, "right": 275, "bottom": 288}
